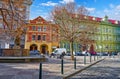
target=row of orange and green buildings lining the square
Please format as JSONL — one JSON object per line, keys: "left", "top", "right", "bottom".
{"left": 25, "top": 16, "right": 120, "bottom": 54}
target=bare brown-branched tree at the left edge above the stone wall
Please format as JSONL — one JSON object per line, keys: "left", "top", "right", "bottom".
{"left": 0, "top": 0, "right": 32, "bottom": 45}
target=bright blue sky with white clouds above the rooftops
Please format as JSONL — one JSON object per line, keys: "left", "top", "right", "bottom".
{"left": 30, "top": 0, "right": 120, "bottom": 20}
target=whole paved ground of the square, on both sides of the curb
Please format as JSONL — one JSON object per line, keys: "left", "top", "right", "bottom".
{"left": 0, "top": 56, "right": 120, "bottom": 79}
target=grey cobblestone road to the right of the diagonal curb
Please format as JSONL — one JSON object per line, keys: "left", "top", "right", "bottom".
{"left": 70, "top": 58, "right": 120, "bottom": 79}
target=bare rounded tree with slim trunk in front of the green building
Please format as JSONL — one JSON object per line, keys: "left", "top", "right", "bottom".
{"left": 51, "top": 3, "right": 99, "bottom": 59}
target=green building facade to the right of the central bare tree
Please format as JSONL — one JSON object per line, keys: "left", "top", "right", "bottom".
{"left": 95, "top": 17, "right": 120, "bottom": 52}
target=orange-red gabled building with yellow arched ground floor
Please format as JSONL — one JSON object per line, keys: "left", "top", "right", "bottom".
{"left": 25, "top": 16, "right": 59, "bottom": 54}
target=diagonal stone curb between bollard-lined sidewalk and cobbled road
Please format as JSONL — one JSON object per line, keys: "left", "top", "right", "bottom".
{"left": 63, "top": 58, "right": 105, "bottom": 79}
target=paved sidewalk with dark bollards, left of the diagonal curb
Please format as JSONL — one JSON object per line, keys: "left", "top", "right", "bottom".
{"left": 0, "top": 56, "right": 113, "bottom": 79}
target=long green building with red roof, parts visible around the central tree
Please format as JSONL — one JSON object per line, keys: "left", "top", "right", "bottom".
{"left": 60, "top": 16, "right": 120, "bottom": 52}
